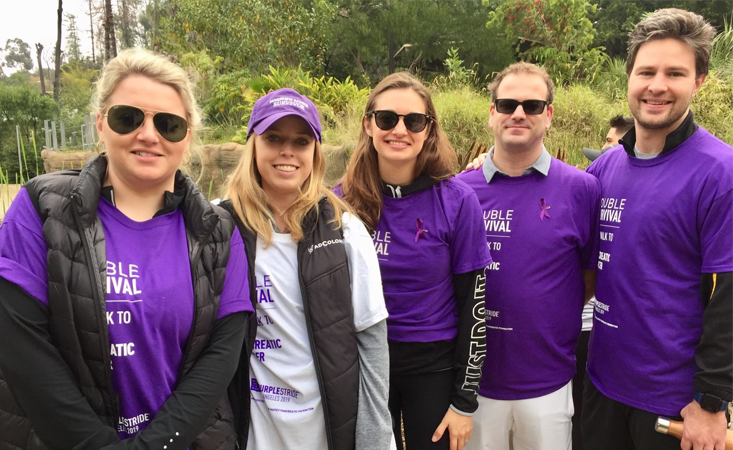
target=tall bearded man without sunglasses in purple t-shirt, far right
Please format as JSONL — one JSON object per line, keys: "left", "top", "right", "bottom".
{"left": 582, "top": 9, "right": 733, "bottom": 450}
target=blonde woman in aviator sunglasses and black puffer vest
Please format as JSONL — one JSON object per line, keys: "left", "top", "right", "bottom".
{"left": 0, "top": 49, "right": 252, "bottom": 450}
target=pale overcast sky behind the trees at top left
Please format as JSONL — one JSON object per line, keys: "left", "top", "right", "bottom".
{"left": 0, "top": 0, "right": 97, "bottom": 73}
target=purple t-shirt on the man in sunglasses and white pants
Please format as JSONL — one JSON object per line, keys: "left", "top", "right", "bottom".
{"left": 459, "top": 158, "right": 601, "bottom": 400}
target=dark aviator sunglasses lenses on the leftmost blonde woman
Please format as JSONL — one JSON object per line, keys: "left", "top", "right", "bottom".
{"left": 104, "top": 105, "right": 188, "bottom": 142}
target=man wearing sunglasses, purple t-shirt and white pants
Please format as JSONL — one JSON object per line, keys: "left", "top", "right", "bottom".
{"left": 459, "top": 63, "right": 600, "bottom": 450}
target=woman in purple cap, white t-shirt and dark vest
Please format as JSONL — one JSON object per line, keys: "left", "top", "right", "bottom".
{"left": 223, "top": 89, "right": 393, "bottom": 450}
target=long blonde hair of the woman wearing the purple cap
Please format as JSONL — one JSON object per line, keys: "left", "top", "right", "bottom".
{"left": 225, "top": 132, "right": 351, "bottom": 247}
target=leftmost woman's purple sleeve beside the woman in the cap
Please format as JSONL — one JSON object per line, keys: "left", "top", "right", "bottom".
{"left": 216, "top": 229, "right": 254, "bottom": 319}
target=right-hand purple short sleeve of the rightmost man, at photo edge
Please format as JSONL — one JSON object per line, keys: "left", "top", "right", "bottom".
{"left": 700, "top": 190, "right": 733, "bottom": 273}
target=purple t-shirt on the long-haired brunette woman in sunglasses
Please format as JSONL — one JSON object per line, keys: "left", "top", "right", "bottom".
{"left": 372, "top": 178, "right": 491, "bottom": 342}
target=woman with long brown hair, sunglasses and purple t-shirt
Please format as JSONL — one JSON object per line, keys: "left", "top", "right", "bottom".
{"left": 340, "top": 73, "right": 491, "bottom": 450}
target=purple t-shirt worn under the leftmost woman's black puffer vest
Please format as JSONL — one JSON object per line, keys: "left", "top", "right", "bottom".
{"left": 0, "top": 189, "right": 252, "bottom": 439}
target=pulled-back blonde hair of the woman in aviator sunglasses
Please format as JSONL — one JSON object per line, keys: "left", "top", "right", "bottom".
{"left": 91, "top": 48, "right": 201, "bottom": 147}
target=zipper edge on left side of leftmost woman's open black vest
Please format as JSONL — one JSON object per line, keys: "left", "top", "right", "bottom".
{"left": 70, "top": 194, "right": 120, "bottom": 422}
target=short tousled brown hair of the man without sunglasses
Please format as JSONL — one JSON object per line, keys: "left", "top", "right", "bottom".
{"left": 626, "top": 8, "right": 715, "bottom": 77}
